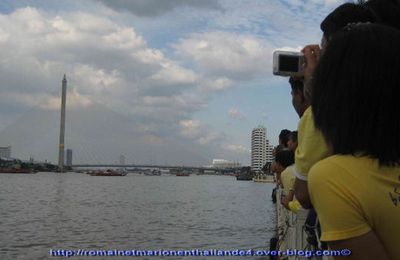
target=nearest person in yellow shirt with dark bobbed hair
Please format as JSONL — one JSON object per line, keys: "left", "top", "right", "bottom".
{"left": 308, "top": 23, "right": 400, "bottom": 259}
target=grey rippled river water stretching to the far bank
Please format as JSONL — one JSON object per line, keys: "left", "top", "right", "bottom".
{"left": 0, "top": 173, "right": 275, "bottom": 259}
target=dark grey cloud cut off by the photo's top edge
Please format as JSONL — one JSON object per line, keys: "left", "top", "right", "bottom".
{"left": 96, "top": 0, "right": 222, "bottom": 16}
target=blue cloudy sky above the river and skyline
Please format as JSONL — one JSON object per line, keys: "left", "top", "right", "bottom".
{"left": 0, "top": 0, "right": 345, "bottom": 165}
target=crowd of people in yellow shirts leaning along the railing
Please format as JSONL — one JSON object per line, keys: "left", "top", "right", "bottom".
{"left": 271, "top": 0, "right": 400, "bottom": 259}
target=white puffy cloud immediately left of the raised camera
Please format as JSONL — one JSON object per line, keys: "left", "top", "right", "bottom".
{"left": 173, "top": 31, "right": 272, "bottom": 80}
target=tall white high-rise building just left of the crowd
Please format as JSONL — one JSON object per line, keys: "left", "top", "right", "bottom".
{"left": 251, "top": 125, "right": 273, "bottom": 171}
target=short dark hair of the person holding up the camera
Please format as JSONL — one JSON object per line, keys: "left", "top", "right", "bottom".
{"left": 321, "top": 3, "right": 378, "bottom": 40}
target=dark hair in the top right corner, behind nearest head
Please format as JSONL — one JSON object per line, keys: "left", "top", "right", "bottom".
{"left": 364, "top": 0, "right": 400, "bottom": 30}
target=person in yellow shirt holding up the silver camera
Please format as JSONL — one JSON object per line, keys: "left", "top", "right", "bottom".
{"left": 295, "top": 3, "right": 377, "bottom": 208}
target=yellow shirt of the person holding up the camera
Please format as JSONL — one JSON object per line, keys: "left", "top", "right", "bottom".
{"left": 294, "top": 106, "right": 329, "bottom": 181}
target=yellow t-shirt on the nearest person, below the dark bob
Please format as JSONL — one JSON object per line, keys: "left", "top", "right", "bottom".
{"left": 308, "top": 155, "right": 400, "bottom": 259}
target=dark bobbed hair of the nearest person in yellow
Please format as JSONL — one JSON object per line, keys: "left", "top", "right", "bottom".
{"left": 311, "top": 24, "right": 400, "bottom": 166}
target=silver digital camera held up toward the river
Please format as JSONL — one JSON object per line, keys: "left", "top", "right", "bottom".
{"left": 273, "top": 51, "right": 304, "bottom": 77}
